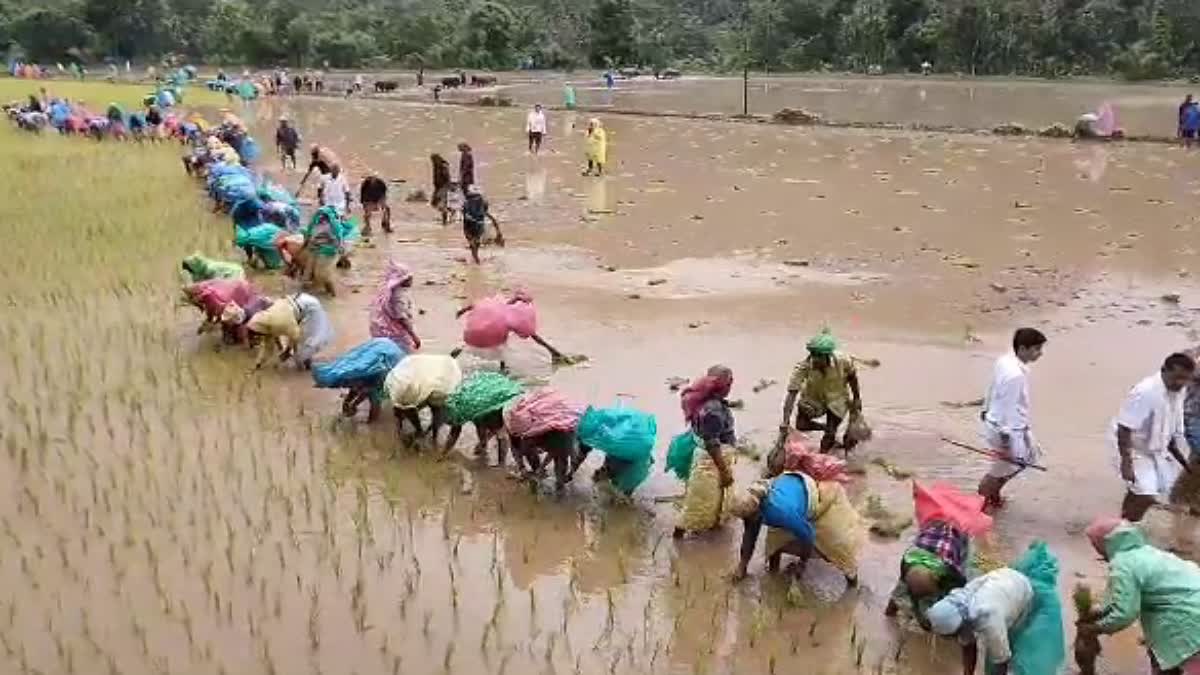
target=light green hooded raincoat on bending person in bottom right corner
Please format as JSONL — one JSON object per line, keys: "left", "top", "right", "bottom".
{"left": 1098, "top": 525, "right": 1200, "bottom": 670}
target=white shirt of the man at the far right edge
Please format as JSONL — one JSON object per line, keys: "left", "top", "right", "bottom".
{"left": 1112, "top": 372, "right": 1188, "bottom": 456}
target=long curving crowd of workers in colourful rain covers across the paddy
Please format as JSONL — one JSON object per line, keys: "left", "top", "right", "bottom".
{"left": 14, "top": 73, "right": 1200, "bottom": 675}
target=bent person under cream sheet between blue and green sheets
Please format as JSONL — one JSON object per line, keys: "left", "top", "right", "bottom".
{"left": 384, "top": 354, "right": 462, "bottom": 449}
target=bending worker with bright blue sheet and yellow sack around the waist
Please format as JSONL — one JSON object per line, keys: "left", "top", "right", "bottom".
{"left": 730, "top": 435, "right": 866, "bottom": 585}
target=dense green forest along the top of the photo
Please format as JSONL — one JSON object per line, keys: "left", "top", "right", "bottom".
{"left": 0, "top": 0, "right": 1200, "bottom": 79}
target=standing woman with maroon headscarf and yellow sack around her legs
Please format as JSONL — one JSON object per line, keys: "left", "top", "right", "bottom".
{"left": 672, "top": 365, "right": 736, "bottom": 538}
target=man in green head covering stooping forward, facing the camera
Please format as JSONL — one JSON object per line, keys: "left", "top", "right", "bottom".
{"left": 779, "top": 330, "right": 863, "bottom": 453}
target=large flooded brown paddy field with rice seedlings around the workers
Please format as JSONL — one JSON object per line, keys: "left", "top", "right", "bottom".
{"left": 0, "top": 82, "right": 1200, "bottom": 675}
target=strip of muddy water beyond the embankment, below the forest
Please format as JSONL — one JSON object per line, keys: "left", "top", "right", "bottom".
{"left": 504, "top": 74, "right": 1190, "bottom": 136}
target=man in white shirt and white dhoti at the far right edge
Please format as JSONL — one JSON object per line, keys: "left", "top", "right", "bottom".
{"left": 1112, "top": 354, "right": 1196, "bottom": 522}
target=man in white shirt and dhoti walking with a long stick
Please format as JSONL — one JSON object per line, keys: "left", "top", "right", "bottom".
{"left": 979, "top": 328, "right": 1046, "bottom": 509}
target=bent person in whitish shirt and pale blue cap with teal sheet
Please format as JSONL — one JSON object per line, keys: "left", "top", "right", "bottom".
{"left": 926, "top": 542, "right": 1066, "bottom": 675}
